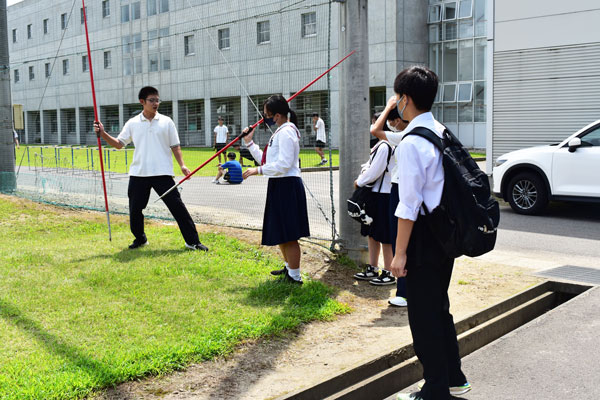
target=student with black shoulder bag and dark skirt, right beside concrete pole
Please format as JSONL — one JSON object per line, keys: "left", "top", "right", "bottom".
{"left": 354, "top": 128, "right": 396, "bottom": 286}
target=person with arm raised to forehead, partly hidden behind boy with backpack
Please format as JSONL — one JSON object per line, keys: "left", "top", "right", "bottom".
{"left": 371, "top": 105, "right": 407, "bottom": 307}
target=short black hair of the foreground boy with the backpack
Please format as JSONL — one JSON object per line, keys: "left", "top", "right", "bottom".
{"left": 394, "top": 65, "right": 438, "bottom": 111}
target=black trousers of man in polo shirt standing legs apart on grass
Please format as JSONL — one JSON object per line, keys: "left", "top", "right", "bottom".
{"left": 127, "top": 175, "right": 200, "bottom": 245}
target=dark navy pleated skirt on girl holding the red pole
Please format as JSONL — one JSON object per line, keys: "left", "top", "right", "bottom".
{"left": 262, "top": 176, "right": 310, "bottom": 246}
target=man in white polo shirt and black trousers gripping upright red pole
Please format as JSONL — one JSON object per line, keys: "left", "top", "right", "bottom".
{"left": 94, "top": 86, "right": 208, "bottom": 251}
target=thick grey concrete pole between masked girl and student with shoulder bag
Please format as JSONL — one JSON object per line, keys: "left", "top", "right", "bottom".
{"left": 339, "top": 0, "right": 371, "bottom": 262}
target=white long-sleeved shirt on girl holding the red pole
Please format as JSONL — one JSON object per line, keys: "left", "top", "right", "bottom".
{"left": 248, "top": 122, "right": 300, "bottom": 178}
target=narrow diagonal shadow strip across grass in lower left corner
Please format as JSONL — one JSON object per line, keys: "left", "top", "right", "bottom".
{"left": 0, "top": 299, "right": 118, "bottom": 396}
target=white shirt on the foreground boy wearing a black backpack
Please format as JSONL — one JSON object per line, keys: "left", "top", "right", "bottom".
{"left": 395, "top": 112, "right": 444, "bottom": 221}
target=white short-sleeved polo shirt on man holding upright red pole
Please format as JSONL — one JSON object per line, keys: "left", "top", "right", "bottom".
{"left": 117, "top": 112, "right": 179, "bottom": 176}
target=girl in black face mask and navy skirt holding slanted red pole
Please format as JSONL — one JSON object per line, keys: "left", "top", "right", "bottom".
{"left": 243, "top": 95, "right": 310, "bottom": 284}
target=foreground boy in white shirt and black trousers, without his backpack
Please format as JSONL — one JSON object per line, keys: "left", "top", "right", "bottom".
{"left": 384, "top": 66, "right": 471, "bottom": 400}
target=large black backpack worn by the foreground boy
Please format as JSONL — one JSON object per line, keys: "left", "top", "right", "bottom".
{"left": 403, "top": 127, "right": 500, "bottom": 258}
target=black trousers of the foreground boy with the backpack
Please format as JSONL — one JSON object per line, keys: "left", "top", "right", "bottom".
{"left": 406, "top": 215, "right": 467, "bottom": 400}
